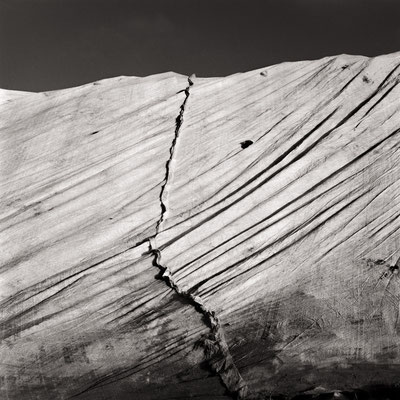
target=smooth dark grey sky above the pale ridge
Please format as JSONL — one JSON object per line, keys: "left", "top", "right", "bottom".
{"left": 0, "top": 0, "right": 400, "bottom": 91}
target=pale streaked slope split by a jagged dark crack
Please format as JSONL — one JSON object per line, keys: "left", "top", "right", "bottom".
{"left": 0, "top": 53, "right": 400, "bottom": 400}
